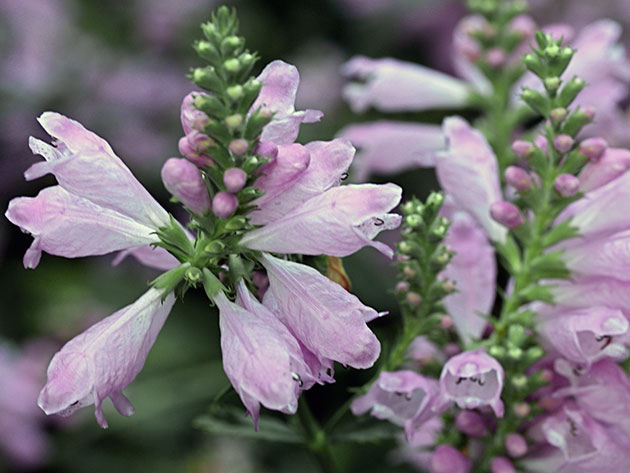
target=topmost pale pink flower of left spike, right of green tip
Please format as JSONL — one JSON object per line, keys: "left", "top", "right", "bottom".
{"left": 251, "top": 61, "right": 323, "bottom": 145}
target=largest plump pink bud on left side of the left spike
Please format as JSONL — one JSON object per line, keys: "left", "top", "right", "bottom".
{"left": 162, "top": 158, "right": 210, "bottom": 215}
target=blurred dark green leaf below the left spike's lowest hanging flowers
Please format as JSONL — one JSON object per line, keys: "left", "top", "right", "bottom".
{"left": 193, "top": 407, "right": 305, "bottom": 444}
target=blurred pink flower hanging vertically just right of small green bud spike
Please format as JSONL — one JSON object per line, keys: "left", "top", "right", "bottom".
{"left": 442, "top": 211, "right": 497, "bottom": 344}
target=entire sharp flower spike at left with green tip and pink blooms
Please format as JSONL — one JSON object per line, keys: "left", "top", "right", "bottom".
{"left": 6, "top": 8, "right": 401, "bottom": 428}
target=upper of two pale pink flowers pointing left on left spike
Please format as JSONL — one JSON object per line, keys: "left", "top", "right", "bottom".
{"left": 25, "top": 112, "right": 169, "bottom": 228}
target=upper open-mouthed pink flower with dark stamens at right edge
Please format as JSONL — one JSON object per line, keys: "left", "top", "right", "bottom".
{"left": 536, "top": 306, "right": 629, "bottom": 366}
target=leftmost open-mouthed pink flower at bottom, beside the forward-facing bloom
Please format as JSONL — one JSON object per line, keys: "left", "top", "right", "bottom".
{"left": 350, "top": 370, "right": 439, "bottom": 426}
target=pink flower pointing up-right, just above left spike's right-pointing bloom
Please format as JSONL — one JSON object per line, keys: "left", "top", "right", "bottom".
{"left": 251, "top": 139, "right": 355, "bottom": 225}
